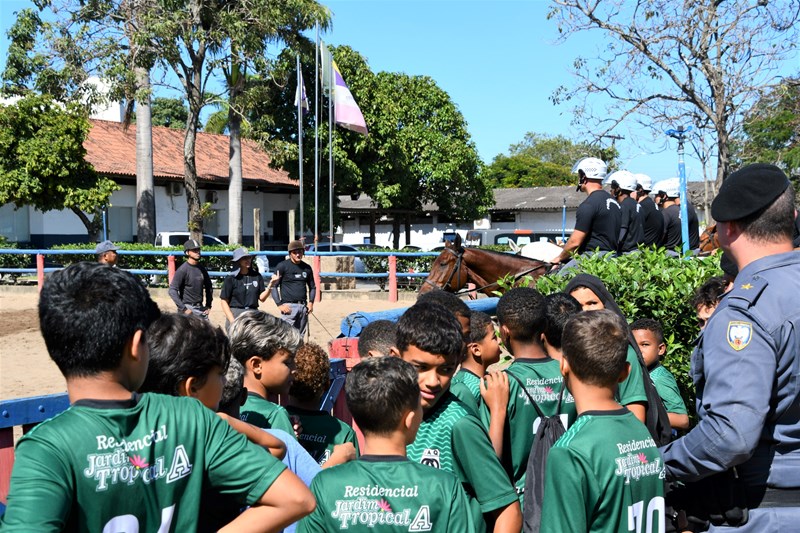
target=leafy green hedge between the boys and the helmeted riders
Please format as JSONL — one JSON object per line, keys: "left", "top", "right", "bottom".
{"left": 536, "top": 249, "right": 722, "bottom": 414}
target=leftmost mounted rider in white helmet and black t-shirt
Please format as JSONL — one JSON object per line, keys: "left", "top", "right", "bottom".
{"left": 550, "top": 157, "right": 622, "bottom": 267}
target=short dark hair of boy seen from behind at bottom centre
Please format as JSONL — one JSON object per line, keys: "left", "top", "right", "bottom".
{"left": 344, "top": 357, "right": 420, "bottom": 435}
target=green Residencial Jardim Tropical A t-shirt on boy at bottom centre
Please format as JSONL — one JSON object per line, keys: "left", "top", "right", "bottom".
{"left": 298, "top": 455, "right": 475, "bottom": 533}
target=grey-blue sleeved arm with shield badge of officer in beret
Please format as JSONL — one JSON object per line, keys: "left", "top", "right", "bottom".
{"left": 661, "top": 307, "right": 776, "bottom": 481}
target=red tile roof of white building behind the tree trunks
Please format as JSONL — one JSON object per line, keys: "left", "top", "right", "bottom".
{"left": 83, "top": 119, "right": 297, "bottom": 187}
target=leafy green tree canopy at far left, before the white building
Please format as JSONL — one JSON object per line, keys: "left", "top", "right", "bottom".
{"left": 0, "top": 95, "right": 120, "bottom": 236}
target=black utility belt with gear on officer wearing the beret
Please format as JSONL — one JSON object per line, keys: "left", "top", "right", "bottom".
{"left": 667, "top": 467, "right": 800, "bottom": 531}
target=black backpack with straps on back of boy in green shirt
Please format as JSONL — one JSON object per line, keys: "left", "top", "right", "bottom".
{"left": 506, "top": 372, "right": 566, "bottom": 533}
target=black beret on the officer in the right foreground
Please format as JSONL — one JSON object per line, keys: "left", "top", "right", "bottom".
{"left": 711, "top": 163, "right": 789, "bottom": 222}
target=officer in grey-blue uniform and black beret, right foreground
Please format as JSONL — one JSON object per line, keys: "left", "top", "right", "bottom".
{"left": 661, "top": 164, "right": 800, "bottom": 533}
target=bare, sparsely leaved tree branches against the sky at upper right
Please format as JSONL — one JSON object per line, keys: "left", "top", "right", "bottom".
{"left": 549, "top": 0, "right": 800, "bottom": 184}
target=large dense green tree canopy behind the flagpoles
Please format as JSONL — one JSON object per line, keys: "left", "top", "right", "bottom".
{"left": 251, "top": 46, "right": 492, "bottom": 230}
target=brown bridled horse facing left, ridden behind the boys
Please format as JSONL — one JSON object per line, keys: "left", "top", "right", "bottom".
{"left": 419, "top": 236, "right": 550, "bottom": 296}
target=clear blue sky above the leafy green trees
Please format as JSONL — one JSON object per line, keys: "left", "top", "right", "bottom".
{"left": 0, "top": 0, "right": 792, "bottom": 181}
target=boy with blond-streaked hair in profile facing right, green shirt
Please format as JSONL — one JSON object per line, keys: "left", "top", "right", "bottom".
{"left": 229, "top": 311, "right": 301, "bottom": 435}
